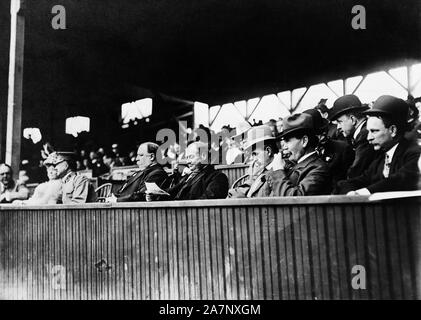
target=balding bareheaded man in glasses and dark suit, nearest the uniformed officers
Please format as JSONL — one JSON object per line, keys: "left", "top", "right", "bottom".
{"left": 106, "top": 142, "right": 168, "bottom": 202}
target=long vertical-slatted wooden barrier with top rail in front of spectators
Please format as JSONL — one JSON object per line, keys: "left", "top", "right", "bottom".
{"left": 0, "top": 196, "right": 421, "bottom": 299}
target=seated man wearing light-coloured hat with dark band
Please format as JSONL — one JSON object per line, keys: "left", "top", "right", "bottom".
{"left": 228, "top": 125, "right": 280, "bottom": 198}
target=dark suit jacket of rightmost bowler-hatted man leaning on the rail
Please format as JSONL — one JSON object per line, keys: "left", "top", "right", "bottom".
{"left": 338, "top": 139, "right": 420, "bottom": 193}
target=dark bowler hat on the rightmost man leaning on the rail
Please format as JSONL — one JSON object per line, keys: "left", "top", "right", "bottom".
{"left": 364, "top": 95, "right": 409, "bottom": 124}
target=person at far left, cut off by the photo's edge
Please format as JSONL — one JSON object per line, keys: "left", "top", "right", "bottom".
{"left": 0, "top": 163, "right": 29, "bottom": 203}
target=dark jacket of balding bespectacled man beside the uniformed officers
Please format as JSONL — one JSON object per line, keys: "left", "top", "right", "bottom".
{"left": 115, "top": 164, "right": 168, "bottom": 202}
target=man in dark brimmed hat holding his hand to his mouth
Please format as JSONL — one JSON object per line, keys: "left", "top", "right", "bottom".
{"left": 268, "top": 113, "right": 331, "bottom": 197}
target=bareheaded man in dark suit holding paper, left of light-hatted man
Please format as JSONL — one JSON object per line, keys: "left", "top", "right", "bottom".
{"left": 156, "top": 141, "right": 228, "bottom": 200}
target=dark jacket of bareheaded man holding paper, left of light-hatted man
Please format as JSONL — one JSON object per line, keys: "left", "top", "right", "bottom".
{"left": 168, "top": 165, "right": 228, "bottom": 200}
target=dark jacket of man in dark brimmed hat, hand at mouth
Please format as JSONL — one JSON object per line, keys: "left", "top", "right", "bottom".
{"left": 269, "top": 154, "right": 332, "bottom": 197}
